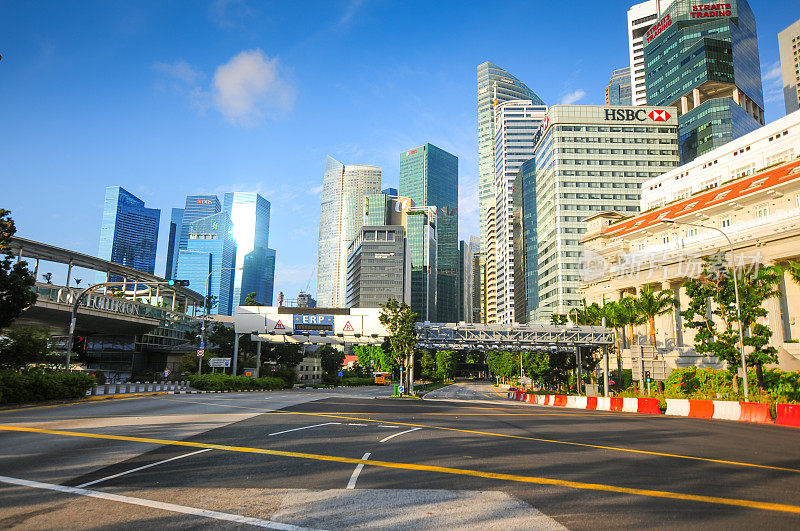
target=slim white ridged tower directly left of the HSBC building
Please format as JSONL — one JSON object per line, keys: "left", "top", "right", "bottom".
{"left": 486, "top": 100, "right": 547, "bottom": 323}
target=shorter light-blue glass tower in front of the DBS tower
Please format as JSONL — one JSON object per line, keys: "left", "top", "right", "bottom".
{"left": 176, "top": 212, "right": 236, "bottom": 315}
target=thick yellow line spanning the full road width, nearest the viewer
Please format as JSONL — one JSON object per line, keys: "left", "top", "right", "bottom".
{"left": 0, "top": 425, "right": 800, "bottom": 514}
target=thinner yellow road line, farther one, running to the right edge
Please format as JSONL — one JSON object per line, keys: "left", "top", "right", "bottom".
{"left": 162, "top": 399, "right": 800, "bottom": 472}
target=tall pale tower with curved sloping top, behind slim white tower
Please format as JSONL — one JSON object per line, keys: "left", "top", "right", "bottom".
{"left": 477, "top": 61, "right": 544, "bottom": 320}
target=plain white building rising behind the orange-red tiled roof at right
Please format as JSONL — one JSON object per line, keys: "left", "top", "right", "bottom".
{"left": 642, "top": 111, "right": 800, "bottom": 212}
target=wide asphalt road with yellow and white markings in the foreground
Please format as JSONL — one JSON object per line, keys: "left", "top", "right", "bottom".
{"left": 0, "top": 384, "right": 800, "bottom": 529}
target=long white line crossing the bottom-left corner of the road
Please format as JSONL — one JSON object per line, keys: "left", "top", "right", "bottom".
{"left": 0, "top": 476, "right": 318, "bottom": 531}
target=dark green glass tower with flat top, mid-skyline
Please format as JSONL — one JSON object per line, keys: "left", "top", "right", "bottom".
{"left": 400, "top": 144, "right": 458, "bottom": 323}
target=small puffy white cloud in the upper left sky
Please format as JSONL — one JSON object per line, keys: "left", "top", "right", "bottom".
{"left": 213, "top": 49, "right": 295, "bottom": 126}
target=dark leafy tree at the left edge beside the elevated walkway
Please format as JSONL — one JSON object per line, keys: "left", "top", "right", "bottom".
{"left": 0, "top": 209, "right": 36, "bottom": 330}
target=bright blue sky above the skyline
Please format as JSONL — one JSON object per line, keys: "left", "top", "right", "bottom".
{"left": 0, "top": 0, "right": 800, "bottom": 298}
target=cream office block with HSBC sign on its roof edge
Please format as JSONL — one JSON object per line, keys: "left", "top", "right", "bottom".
{"left": 536, "top": 105, "right": 679, "bottom": 320}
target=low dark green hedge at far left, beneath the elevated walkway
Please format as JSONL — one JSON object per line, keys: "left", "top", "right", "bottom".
{"left": 0, "top": 368, "right": 95, "bottom": 404}
